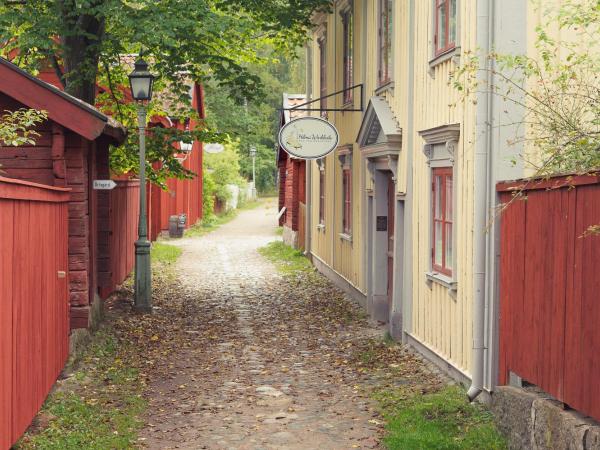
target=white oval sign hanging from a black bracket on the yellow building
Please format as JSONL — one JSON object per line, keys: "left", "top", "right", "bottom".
{"left": 279, "top": 117, "right": 340, "bottom": 159}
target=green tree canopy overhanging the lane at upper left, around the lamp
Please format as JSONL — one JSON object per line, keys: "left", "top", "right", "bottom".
{"left": 0, "top": 0, "right": 330, "bottom": 183}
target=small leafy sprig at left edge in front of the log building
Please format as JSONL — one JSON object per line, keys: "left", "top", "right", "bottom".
{"left": 0, "top": 109, "right": 48, "bottom": 146}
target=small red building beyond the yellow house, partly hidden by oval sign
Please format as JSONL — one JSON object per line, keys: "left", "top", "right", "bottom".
{"left": 277, "top": 94, "right": 306, "bottom": 248}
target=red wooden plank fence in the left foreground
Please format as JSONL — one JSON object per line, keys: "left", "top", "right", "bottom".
{"left": 0, "top": 177, "right": 69, "bottom": 449}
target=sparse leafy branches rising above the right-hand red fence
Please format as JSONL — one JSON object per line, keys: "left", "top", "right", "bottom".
{"left": 454, "top": 0, "right": 600, "bottom": 176}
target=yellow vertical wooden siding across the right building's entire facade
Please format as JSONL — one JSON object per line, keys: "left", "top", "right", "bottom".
{"left": 308, "top": 0, "right": 560, "bottom": 374}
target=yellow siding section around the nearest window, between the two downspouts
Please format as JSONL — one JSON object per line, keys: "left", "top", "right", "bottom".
{"left": 409, "top": 0, "right": 476, "bottom": 373}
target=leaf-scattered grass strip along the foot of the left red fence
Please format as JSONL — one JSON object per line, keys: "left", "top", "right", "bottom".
{"left": 16, "top": 328, "right": 146, "bottom": 450}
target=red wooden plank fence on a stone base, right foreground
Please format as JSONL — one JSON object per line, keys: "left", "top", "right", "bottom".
{"left": 498, "top": 176, "right": 600, "bottom": 420}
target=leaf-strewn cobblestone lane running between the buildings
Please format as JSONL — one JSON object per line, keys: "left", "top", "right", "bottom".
{"left": 141, "top": 201, "right": 381, "bottom": 450}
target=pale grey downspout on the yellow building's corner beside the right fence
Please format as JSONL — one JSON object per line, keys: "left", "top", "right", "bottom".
{"left": 467, "top": 0, "right": 494, "bottom": 401}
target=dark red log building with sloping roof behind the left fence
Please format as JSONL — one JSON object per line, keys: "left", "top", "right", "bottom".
{"left": 0, "top": 59, "right": 125, "bottom": 328}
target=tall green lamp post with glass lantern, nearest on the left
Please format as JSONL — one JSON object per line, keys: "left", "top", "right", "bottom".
{"left": 129, "top": 58, "right": 154, "bottom": 312}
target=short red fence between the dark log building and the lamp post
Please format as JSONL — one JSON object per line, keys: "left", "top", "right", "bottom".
{"left": 101, "top": 180, "right": 140, "bottom": 298}
